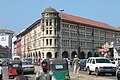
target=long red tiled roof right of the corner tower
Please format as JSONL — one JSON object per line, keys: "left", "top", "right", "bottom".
{"left": 59, "top": 13, "right": 120, "bottom": 31}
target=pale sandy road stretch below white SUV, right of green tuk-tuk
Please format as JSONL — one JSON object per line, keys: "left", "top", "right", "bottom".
{"left": 69, "top": 67, "right": 117, "bottom": 80}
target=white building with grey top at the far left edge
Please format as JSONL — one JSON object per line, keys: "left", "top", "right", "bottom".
{"left": 0, "top": 29, "right": 14, "bottom": 58}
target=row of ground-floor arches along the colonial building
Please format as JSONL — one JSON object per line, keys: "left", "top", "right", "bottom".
{"left": 26, "top": 51, "right": 93, "bottom": 59}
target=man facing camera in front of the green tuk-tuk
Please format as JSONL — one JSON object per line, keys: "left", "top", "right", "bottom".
{"left": 35, "top": 61, "right": 51, "bottom": 80}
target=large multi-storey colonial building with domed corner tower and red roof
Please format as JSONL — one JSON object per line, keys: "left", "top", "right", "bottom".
{"left": 14, "top": 7, "right": 120, "bottom": 59}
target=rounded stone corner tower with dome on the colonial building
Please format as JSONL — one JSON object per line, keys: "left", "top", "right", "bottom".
{"left": 41, "top": 7, "right": 60, "bottom": 58}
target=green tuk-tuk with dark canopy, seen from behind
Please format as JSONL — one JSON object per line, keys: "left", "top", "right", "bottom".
{"left": 47, "top": 59, "right": 70, "bottom": 80}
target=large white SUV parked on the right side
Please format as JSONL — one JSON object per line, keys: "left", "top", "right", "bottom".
{"left": 86, "top": 57, "right": 116, "bottom": 75}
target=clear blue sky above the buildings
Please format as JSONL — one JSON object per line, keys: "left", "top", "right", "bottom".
{"left": 0, "top": 0, "right": 120, "bottom": 33}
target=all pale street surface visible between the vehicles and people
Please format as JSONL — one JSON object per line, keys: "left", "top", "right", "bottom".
{"left": 3, "top": 66, "right": 117, "bottom": 80}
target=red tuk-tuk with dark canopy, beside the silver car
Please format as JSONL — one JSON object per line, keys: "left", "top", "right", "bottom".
{"left": 8, "top": 60, "right": 22, "bottom": 79}
